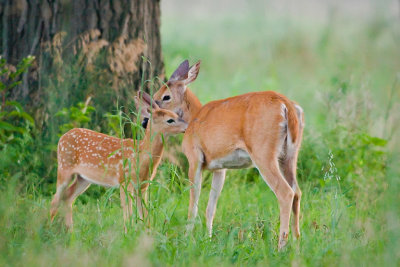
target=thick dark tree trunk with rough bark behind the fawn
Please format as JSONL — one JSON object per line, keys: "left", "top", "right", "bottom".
{"left": 0, "top": 0, "right": 164, "bottom": 121}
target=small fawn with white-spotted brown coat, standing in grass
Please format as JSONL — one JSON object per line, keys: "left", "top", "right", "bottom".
{"left": 50, "top": 93, "right": 187, "bottom": 231}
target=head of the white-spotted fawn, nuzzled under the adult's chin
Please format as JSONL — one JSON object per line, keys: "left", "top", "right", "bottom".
{"left": 135, "top": 92, "right": 188, "bottom": 134}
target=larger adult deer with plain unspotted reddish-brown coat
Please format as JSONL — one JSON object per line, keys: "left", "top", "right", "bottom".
{"left": 154, "top": 60, "right": 304, "bottom": 249}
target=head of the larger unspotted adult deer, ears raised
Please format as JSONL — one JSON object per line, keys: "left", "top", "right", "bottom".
{"left": 153, "top": 60, "right": 201, "bottom": 120}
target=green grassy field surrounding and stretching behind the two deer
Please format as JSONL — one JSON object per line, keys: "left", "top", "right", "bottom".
{"left": 0, "top": 1, "right": 400, "bottom": 266}
